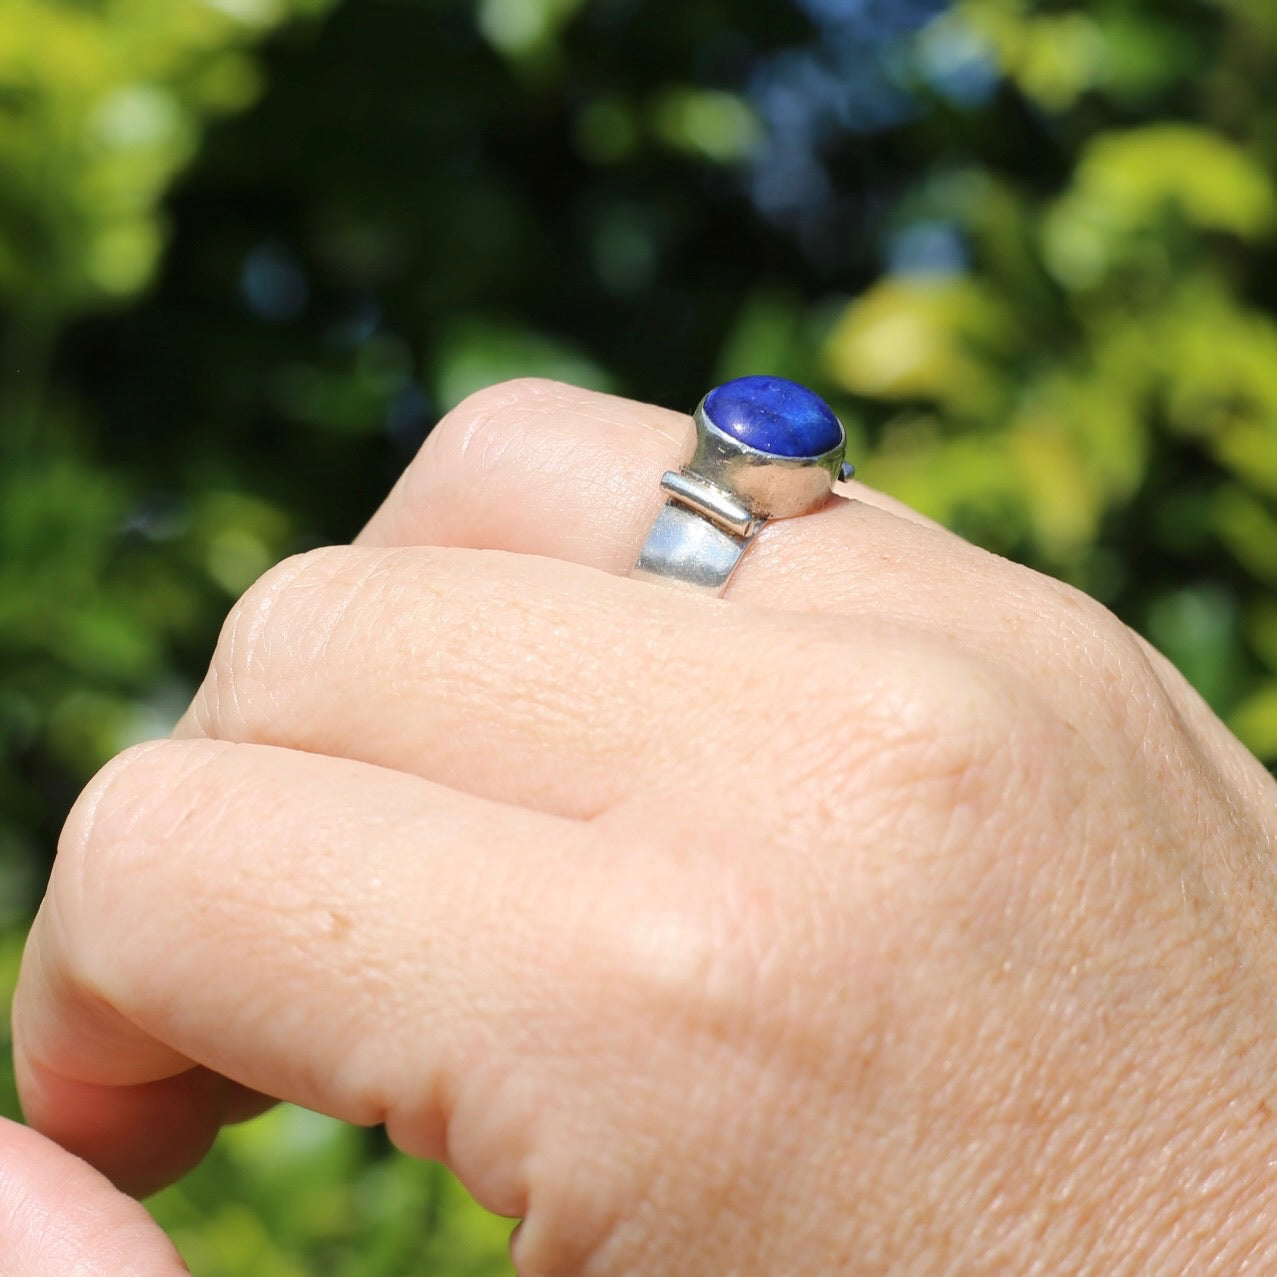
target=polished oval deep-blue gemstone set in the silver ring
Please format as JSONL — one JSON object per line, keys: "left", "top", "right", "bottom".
{"left": 705, "top": 377, "right": 843, "bottom": 457}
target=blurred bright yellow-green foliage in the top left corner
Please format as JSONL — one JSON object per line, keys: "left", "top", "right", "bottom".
{"left": 0, "top": 0, "right": 328, "bottom": 316}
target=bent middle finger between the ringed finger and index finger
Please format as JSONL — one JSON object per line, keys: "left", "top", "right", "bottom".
{"left": 169, "top": 547, "right": 965, "bottom": 817}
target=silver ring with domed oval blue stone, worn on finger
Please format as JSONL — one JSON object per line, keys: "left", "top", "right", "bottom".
{"left": 631, "top": 377, "right": 856, "bottom": 595}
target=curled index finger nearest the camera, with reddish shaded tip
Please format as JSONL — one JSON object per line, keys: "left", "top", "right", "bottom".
{"left": 14, "top": 741, "right": 626, "bottom": 1205}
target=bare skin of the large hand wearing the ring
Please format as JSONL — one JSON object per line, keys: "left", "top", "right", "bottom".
{"left": 7, "top": 382, "right": 1277, "bottom": 1277}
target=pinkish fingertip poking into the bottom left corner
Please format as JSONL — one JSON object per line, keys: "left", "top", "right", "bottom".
{"left": 0, "top": 1120, "right": 189, "bottom": 1277}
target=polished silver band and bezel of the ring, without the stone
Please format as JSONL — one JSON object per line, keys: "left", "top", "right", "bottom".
{"left": 631, "top": 400, "right": 854, "bottom": 595}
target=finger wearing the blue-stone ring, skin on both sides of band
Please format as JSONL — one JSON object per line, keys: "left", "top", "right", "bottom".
{"left": 347, "top": 381, "right": 1176, "bottom": 740}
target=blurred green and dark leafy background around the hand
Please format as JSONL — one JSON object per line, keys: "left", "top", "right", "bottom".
{"left": 0, "top": 0, "right": 1277, "bottom": 1277}
